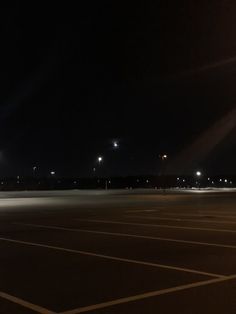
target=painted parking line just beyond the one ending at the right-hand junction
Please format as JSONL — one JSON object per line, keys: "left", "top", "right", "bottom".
{"left": 17, "top": 223, "right": 236, "bottom": 249}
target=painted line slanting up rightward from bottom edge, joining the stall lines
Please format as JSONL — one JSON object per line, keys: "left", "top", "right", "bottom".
{"left": 61, "top": 275, "right": 236, "bottom": 314}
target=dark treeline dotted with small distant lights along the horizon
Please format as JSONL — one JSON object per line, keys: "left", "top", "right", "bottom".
{"left": 0, "top": 175, "right": 233, "bottom": 191}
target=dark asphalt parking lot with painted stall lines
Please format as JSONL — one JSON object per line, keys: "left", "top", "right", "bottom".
{"left": 0, "top": 190, "right": 236, "bottom": 314}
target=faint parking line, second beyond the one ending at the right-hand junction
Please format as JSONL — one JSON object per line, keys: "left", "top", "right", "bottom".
{"left": 75, "top": 218, "right": 236, "bottom": 233}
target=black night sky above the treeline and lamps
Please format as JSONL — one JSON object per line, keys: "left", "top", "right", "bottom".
{"left": 0, "top": 0, "right": 236, "bottom": 176}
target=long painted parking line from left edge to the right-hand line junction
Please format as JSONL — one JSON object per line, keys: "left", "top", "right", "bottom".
{"left": 0, "top": 238, "right": 223, "bottom": 278}
